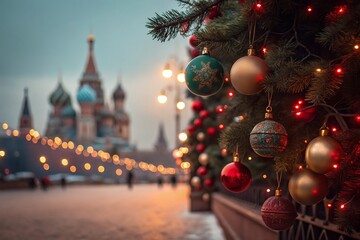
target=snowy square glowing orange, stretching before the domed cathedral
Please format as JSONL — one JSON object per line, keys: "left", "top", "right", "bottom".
{"left": 0, "top": 185, "right": 223, "bottom": 240}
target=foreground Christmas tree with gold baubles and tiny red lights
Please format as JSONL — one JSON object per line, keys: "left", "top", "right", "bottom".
{"left": 147, "top": 0, "right": 360, "bottom": 231}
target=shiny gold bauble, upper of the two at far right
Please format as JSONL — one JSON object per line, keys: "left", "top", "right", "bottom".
{"left": 305, "top": 128, "right": 343, "bottom": 174}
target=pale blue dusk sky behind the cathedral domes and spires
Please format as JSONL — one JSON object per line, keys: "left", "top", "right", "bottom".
{"left": 0, "top": 0, "right": 191, "bottom": 149}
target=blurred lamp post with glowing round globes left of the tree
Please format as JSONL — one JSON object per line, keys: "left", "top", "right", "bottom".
{"left": 158, "top": 63, "right": 185, "bottom": 147}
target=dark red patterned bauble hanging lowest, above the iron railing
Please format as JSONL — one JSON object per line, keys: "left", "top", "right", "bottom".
{"left": 261, "top": 190, "right": 297, "bottom": 230}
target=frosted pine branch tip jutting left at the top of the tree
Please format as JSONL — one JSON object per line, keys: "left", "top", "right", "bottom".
{"left": 146, "top": 0, "right": 226, "bottom": 42}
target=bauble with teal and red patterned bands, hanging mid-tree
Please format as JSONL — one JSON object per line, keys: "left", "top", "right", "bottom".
{"left": 250, "top": 113, "right": 287, "bottom": 158}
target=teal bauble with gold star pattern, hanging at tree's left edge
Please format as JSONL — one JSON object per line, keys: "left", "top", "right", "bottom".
{"left": 185, "top": 48, "right": 224, "bottom": 97}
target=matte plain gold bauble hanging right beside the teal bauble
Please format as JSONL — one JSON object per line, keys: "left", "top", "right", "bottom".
{"left": 230, "top": 49, "right": 269, "bottom": 95}
